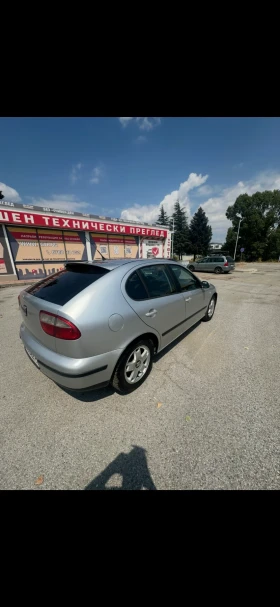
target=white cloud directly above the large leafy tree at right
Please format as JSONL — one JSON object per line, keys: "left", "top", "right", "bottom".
{"left": 201, "top": 171, "right": 280, "bottom": 242}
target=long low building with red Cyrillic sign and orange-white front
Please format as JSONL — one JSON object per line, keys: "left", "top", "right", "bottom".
{"left": 0, "top": 200, "right": 171, "bottom": 281}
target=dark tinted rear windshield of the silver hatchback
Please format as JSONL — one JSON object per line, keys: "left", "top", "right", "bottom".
{"left": 28, "top": 264, "right": 109, "bottom": 306}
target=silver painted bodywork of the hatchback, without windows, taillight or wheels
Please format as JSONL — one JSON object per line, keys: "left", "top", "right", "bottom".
{"left": 20, "top": 260, "right": 216, "bottom": 390}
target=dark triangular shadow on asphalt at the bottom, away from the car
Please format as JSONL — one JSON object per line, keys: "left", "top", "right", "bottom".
{"left": 85, "top": 445, "right": 156, "bottom": 491}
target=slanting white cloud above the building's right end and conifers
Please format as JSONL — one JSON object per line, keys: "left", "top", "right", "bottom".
{"left": 121, "top": 173, "right": 208, "bottom": 223}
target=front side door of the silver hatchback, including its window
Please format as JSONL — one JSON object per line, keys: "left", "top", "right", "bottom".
{"left": 168, "top": 264, "right": 208, "bottom": 332}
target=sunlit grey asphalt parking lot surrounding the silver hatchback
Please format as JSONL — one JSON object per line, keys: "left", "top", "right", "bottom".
{"left": 0, "top": 264, "right": 280, "bottom": 490}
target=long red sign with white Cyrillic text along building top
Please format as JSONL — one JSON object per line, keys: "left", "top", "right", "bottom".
{"left": 0, "top": 210, "right": 167, "bottom": 238}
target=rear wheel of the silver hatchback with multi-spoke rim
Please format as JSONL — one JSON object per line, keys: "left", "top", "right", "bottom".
{"left": 111, "top": 339, "right": 155, "bottom": 394}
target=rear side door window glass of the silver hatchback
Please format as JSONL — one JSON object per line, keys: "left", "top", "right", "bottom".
{"left": 138, "top": 264, "right": 177, "bottom": 298}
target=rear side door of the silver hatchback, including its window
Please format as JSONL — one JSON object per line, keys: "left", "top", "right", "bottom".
{"left": 123, "top": 264, "right": 186, "bottom": 348}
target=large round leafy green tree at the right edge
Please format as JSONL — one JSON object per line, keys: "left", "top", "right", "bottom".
{"left": 226, "top": 190, "right": 280, "bottom": 261}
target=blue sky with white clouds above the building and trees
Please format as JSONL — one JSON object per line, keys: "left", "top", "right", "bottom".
{"left": 0, "top": 118, "right": 280, "bottom": 241}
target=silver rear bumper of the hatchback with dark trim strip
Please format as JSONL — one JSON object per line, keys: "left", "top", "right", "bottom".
{"left": 20, "top": 324, "right": 122, "bottom": 390}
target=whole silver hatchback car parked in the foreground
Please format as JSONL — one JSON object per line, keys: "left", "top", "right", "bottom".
{"left": 19, "top": 259, "right": 217, "bottom": 393}
